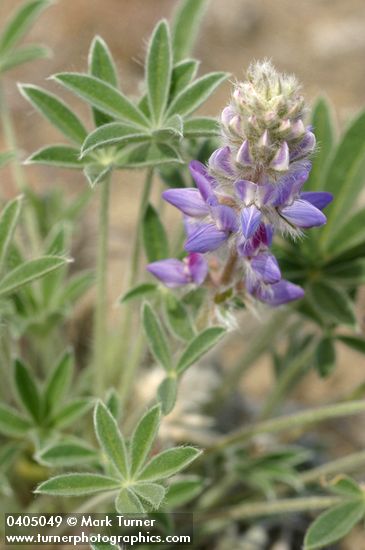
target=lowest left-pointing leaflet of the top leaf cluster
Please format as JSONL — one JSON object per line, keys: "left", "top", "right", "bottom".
{"left": 25, "top": 145, "right": 85, "bottom": 170}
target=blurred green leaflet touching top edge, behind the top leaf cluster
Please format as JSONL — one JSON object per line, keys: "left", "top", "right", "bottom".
{"left": 172, "top": 0, "right": 207, "bottom": 62}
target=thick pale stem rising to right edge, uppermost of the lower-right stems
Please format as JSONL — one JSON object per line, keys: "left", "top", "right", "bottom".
{"left": 205, "top": 401, "right": 365, "bottom": 454}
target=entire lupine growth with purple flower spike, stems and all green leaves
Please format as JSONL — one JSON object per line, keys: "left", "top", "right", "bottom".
{"left": 0, "top": 0, "right": 365, "bottom": 550}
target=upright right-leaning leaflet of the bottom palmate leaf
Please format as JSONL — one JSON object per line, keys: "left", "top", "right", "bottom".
{"left": 130, "top": 405, "right": 161, "bottom": 476}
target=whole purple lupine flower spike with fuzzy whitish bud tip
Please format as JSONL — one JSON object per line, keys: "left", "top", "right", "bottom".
{"left": 148, "top": 61, "right": 332, "bottom": 306}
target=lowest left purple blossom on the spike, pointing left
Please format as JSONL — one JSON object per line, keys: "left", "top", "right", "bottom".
{"left": 147, "top": 254, "right": 208, "bottom": 288}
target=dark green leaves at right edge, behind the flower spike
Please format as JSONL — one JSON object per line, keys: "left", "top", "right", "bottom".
{"left": 275, "top": 98, "right": 365, "bottom": 384}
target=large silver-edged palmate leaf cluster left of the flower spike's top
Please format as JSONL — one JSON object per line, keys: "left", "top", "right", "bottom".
{"left": 21, "top": 14, "right": 228, "bottom": 183}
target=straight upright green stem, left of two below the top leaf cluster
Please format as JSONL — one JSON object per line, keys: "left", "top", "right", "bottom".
{"left": 93, "top": 174, "right": 111, "bottom": 395}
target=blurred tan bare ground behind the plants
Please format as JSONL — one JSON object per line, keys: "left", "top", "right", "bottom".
{"left": 0, "top": 0, "right": 365, "bottom": 550}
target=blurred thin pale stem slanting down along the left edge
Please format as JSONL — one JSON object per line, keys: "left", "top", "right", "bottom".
{"left": 0, "top": 84, "right": 41, "bottom": 253}
